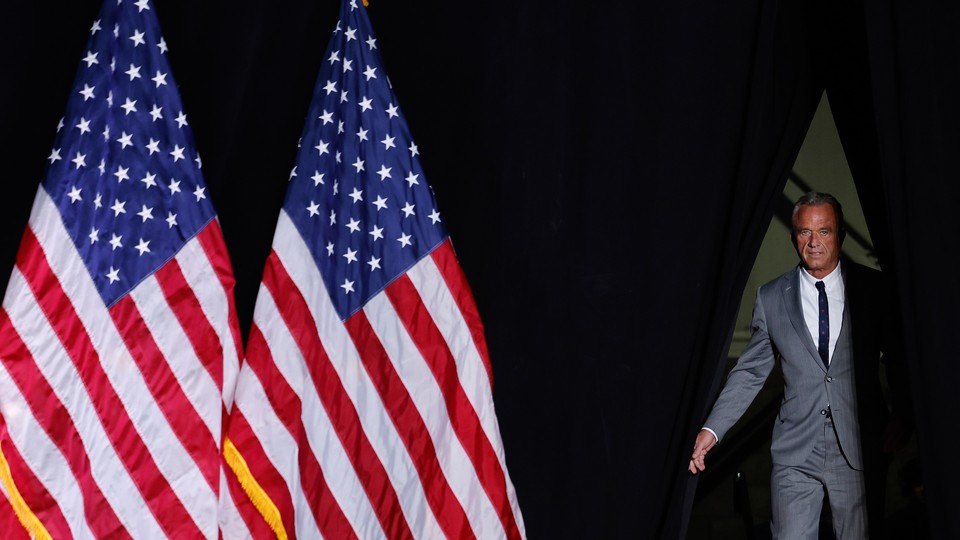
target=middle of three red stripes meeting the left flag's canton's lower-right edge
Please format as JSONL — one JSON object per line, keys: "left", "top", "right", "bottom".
{"left": 154, "top": 259, "right": 223, "bottom": 394}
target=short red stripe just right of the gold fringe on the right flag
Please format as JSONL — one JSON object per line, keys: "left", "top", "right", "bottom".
{"left": 230, "top": 407, "right": 297, "bottom": 538}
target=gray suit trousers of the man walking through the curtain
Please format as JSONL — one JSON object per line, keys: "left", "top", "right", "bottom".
{"left": 770, "top": 418, "right": 867, "bottom": 540}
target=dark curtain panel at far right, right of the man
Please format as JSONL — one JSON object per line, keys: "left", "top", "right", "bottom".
{"left": 865, "top": 0, "right": 960, "bottom": 538}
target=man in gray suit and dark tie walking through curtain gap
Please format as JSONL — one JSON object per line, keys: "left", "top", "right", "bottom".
{"left": 689, "top": 193, "right": 905, "bottom": 540}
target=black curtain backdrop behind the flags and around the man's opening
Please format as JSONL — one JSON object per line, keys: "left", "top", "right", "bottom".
{"left": 0, "top": 0, "right": 960, "bottom": 538}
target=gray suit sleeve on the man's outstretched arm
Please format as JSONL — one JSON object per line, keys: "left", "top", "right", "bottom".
{"left": 704, "top": 289, "right": 776, "bottom": 441}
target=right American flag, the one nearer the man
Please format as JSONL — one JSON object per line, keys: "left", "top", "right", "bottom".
{"left": 222, "top": 1, "right": 525, "bottom": 538}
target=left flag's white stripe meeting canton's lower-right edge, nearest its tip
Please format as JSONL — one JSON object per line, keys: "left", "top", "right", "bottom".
{"left": 130, "top": 275, "right": 221, "bottom": 445}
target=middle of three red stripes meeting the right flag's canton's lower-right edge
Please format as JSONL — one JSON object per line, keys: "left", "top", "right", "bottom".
{"left": 385, "top": 274, "right": 521, "bottom": 538}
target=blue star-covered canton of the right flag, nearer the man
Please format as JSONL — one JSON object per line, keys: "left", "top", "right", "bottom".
{"left": 284, "top": 1, "right": 447, "bottom": 320}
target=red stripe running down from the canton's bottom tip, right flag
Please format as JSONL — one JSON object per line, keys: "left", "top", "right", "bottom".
{"left": 345, "top": 311, "right": 476, "bottom": 538}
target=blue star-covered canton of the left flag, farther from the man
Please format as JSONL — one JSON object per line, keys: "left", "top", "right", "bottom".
{"left": 43, "top": 0, "right": 215, "bottom": 306}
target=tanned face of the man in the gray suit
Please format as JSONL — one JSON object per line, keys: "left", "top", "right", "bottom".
{"left": 793, "top": 204, "right": 840, "bottom": 279}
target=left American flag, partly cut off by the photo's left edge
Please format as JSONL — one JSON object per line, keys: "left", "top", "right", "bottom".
{"left": 0, "top": 0, "right": 240, "bottom": 538}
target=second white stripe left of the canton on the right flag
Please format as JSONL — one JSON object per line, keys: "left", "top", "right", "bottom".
{"left": 253, "top": 285, "right": 386, "bottom": 539}
